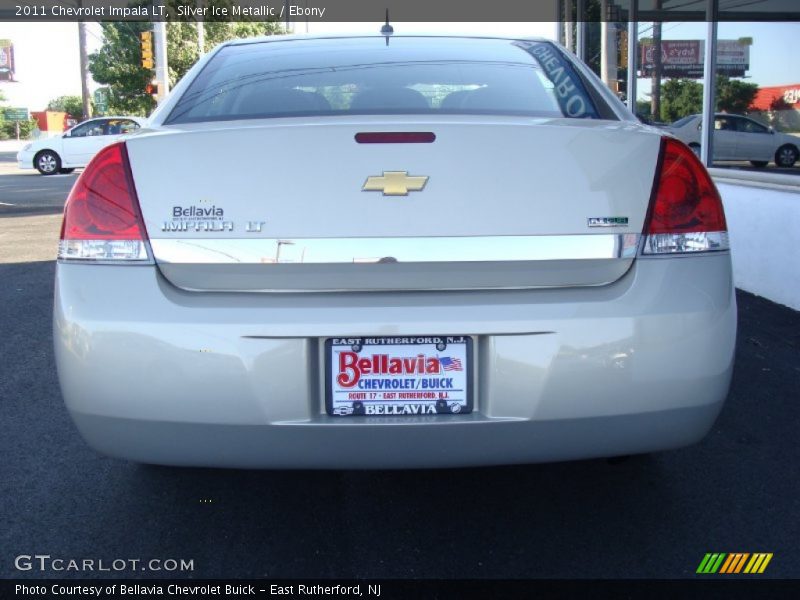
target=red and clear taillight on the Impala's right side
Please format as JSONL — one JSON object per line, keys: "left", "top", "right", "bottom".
{"left": 643, "top": 138, "right": 729, "bottom": 254}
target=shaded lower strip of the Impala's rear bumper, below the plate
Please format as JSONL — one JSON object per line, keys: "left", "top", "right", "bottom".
{"left": 73, "top": 402, "right": 722, "bottom": 469}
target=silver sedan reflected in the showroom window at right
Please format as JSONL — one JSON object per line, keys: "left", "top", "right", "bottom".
{"left": 668, "top": 113, "right": 800, "bottom": 167}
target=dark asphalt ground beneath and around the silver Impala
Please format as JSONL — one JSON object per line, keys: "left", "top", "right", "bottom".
{"left": 0, "top": 146, "right": 800, "bottom": 578}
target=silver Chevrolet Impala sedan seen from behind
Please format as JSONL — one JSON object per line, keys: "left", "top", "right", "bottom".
{"left": 54, "top": 35, "right": 736, "bottom": 468}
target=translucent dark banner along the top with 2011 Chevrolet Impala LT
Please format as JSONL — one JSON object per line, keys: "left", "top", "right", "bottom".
{"left": 0, "top": 0, "right": 800, "bottom": 23}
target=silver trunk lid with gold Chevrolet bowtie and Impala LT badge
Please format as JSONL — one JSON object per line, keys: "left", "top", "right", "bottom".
{"left": 128, "top": 116, "right": 660, "bottom": 291}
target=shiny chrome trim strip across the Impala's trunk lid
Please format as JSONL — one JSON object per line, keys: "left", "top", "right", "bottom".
{"left": 150, "top": 233, "right": 640, "bottom": 264}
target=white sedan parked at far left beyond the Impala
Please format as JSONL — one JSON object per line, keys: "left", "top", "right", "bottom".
{"left": 17, "top": 117, "right": 146, "bottom": 175}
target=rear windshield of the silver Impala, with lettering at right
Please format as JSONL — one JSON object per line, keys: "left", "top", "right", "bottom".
{"left": 166, "top": 37, "right": 599, "bottom": 124}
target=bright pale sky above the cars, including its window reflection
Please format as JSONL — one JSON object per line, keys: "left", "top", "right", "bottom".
{"left": 0, "top": 22, "right": 800, "bottom": 110}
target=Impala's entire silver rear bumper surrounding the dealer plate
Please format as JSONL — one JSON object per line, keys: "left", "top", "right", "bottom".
{"left": 54, "top": 253, "right": 736, "bottom": 468}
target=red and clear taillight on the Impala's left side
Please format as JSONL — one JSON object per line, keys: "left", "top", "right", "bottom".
{"left": 58, "top": 142, "right": 149, "bottom": 261}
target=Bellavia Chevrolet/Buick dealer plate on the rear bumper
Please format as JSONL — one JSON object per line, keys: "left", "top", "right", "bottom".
{"left": 325, "top": 336, "right": 472, "bottom": 417}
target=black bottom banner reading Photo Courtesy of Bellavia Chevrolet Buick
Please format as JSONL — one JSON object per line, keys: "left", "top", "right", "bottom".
{"left": 0, "top": 575, "right": 800, "bottom": 600}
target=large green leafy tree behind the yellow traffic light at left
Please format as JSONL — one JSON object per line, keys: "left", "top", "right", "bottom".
{"left": 89, "top": 0, "right": 280, "bottom": 115}
